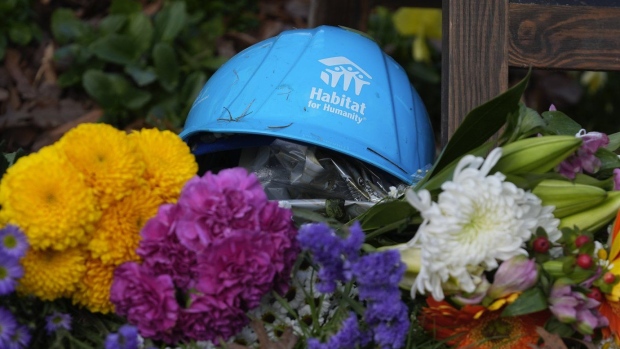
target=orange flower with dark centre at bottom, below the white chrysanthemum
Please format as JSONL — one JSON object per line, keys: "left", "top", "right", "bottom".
{"left": 418, "top": 297, "right": 549, "bottom": 349}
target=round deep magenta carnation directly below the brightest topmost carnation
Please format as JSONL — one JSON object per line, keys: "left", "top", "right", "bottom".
{"left": 197, "top": 231, "right": 277, "bottom": 311}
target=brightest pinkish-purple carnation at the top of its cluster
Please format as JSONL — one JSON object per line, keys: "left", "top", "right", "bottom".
{"left": 177, "top": 167, "right": 268, "bottom": 252}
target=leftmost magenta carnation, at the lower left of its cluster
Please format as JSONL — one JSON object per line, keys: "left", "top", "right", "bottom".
{"left": 110, "top": 262, "right": 179, "bottom": 339}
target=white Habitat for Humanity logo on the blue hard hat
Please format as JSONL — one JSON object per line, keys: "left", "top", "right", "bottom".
{"left": 308, "top": 56, "right": 372, "bottom": 124}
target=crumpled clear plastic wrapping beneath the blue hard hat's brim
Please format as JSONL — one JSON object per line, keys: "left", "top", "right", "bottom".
{"left": 239, "top": 139, "right": 406, "bottom": 203}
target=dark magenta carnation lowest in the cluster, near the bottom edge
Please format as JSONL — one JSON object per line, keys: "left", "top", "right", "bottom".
{"left": 178, "top": 295, "right": 249, "bottom": 344}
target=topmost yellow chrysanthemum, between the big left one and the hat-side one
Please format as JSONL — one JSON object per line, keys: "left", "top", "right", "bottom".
{"left": 59, "top": 124, "right": 144, "bottom": 208}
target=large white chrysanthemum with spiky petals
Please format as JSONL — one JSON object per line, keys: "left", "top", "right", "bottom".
{"left": 406, "top": 148, "right": 561, "bottom": 300}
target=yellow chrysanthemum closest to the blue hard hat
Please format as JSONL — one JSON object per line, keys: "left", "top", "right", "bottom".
{"left": 129, "top": 129, "right": 198, "bottom": 202}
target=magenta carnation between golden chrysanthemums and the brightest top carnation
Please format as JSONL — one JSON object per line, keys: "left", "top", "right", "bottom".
{"left": 137, "top": 204, "right": 198, "bottom": 290}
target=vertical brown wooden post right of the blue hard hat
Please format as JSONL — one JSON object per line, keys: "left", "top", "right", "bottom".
{"left": 441, "top": 0, "right": 508, "bottom": 145}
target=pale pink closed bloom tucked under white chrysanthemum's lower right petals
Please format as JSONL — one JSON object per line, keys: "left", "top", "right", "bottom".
{"left": 487, "top": 255, "right": 538, "bottom": 299}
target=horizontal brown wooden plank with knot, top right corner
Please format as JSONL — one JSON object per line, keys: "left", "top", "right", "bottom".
{"left": 508, "top": 3, "right": 620, "bottom": 70}
